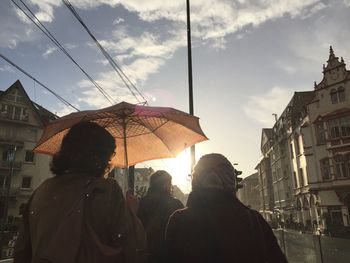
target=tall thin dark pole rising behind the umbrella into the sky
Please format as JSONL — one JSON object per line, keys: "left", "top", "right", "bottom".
{"left": 186, "top": 0, "right": 196, "bottom": 171}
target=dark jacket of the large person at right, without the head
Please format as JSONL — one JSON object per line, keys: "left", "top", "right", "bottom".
{"left": 163, "top": 189, "right": 287, "bottom": 263}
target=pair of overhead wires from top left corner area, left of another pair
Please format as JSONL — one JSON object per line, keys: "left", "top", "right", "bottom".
{"left": 11, "top": 0, "right": 115, "bottom": 105}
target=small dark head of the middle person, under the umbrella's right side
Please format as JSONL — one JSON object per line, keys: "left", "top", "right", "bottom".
{"left": 148, "top": 170, "right": 172, "bottom": 194}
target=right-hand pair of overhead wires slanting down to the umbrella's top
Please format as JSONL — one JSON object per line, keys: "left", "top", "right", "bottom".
{"left": 62, "top": 0, "right": 148, "bottom": 104}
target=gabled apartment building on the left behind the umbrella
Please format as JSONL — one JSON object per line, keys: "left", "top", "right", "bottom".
{"left": 0, "top": 80, "right": 58, "bottom": 225}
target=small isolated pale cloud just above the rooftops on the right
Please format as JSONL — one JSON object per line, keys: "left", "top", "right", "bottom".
{"left": 244, "top": 86, "right": 293, "bottom": 127}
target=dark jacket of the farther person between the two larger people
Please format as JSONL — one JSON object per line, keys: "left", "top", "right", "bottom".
{"left": 137, "top": 192, "right": 184, "bottom": 263}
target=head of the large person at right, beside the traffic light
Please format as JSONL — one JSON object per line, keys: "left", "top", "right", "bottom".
{"left": 192, "top": 153, "right": 237, "bottom": 193}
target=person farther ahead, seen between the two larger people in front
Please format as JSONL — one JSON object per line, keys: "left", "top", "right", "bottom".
{"left": 137, "top": 170, "right": 183, "bottom": 263}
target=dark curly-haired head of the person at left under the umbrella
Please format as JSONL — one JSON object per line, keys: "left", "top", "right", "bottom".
{"left": 51, "top": 122, "right": 116, "bottom": 177}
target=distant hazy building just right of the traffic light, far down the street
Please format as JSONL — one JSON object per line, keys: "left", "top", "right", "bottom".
{"left": 237, "top": 173, "right": 260, "bottom": 211}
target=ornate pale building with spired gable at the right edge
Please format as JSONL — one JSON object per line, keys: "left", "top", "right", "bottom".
{"left": 295, "top": 47, "right": 350, "bottom": 233}
